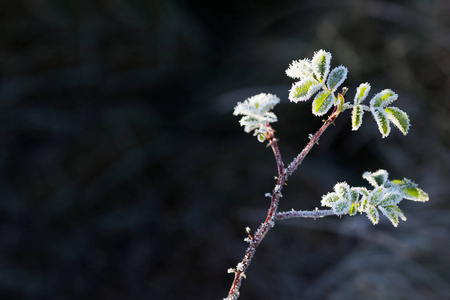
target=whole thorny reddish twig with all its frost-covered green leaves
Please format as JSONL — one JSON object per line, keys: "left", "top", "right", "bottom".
{"left": 226, "top": 50, "right": 428, "bottom": 300}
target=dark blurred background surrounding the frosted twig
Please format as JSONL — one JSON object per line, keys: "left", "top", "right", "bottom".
{"left": 0, "top": 0, "right": 450, "bottom": 300}
